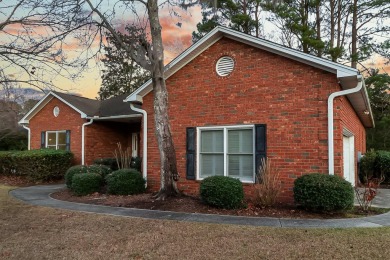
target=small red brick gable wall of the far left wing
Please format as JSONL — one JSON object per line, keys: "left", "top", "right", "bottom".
{"left": 29, "top": 97, "right": 86, "bottom": 164}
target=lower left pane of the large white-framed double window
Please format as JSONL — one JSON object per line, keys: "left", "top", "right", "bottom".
{"left": 200, "top": 154, "right": 223, "bottom": 178}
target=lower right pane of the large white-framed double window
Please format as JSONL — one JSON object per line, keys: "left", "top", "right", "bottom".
{"left": 228, "top": 155, "right": 254, "bottom": 180}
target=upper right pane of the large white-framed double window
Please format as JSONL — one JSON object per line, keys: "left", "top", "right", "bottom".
{"left": 228, "top": 129, "right": 253, "bottom": 153}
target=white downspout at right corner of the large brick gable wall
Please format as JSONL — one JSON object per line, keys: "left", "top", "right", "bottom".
{"left": 328, "top": 76, "right": 364, "bottom": 175}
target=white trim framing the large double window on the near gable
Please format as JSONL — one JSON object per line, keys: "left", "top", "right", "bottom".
{"left": 196, "top": 125, "right": 256, "bottom": 183}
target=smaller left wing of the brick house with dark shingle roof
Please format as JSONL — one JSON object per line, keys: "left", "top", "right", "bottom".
{"left": 19, "top": 91, "right": 141, "bottom": 164}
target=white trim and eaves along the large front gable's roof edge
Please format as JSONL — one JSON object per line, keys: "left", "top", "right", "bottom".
{"left": 124, "top": 26, "right": 374, "bottom": 127}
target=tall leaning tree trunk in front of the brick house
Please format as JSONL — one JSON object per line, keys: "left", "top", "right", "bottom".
{"left": 147, "top": 0, "right": 179, "bottom": 199}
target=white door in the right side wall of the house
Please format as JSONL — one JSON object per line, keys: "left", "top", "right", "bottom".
{"left": 343, "top": 136, "right": 355, "bottom": 186}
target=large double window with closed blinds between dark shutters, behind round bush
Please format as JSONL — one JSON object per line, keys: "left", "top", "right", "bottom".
{"left": 198, "top": 126, "right": 254, "bottom": 182}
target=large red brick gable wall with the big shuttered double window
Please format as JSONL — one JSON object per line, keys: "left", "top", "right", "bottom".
{"left": 143, "top": 38, "right": 364, "bottom": 201}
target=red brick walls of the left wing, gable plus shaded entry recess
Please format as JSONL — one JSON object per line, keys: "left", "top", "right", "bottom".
{"left": 29, "top": 97, "right": 139, "bottom": 165}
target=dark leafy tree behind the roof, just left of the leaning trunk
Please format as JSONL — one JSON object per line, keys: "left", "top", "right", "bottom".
{"left": 98, "top": 30, "right": 150, "bottom": 100}
